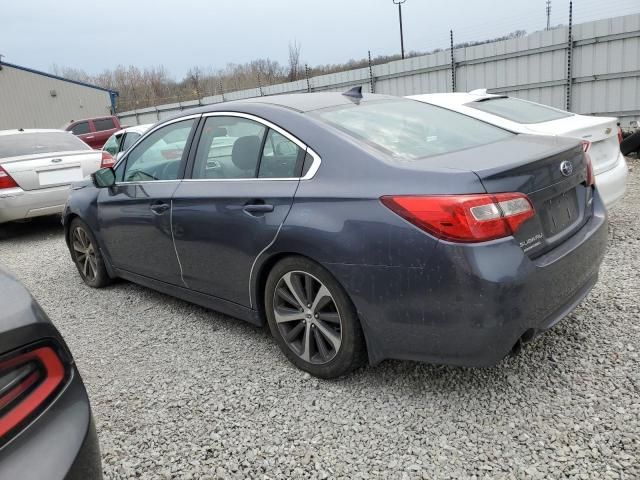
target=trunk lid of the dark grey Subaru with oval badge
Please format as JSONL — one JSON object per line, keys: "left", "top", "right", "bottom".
{"left": 410, "top": 134, "right": 593, "bottom": 258}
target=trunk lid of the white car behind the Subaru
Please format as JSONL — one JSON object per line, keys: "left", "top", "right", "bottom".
{"left": 527, "top": 115, "right": 620, "bottom": 175}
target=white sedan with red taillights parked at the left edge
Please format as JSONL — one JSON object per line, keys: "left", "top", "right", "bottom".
{"left": 0, "top": 129, "right": 106, "bottom": 223}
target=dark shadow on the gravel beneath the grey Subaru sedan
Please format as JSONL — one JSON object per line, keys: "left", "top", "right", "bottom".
{"left": 112, "top": 274, "right": 592, "bottom": 399}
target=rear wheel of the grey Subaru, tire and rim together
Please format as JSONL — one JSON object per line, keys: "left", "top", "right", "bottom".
{"left": 264, "top": 257, "right": 366, "bottom": 378}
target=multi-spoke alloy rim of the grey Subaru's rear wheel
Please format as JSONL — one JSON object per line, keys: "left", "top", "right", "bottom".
{"left": 273, "top": 271, "right": 342, "bottom": 365}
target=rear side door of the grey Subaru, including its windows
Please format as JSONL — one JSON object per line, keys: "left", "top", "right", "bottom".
{"left": 173, "top": 113, "right": 306, "bottom": 307}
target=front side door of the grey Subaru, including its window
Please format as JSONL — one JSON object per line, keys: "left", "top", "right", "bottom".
{"left": 97, "top": 118, "right": 197, "bottom": 285}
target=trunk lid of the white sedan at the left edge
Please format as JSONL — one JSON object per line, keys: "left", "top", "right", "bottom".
{"left": 0, "top": 150, "right": 102, "bottom": 190}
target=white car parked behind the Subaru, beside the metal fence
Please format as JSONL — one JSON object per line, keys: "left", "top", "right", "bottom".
{"left": 407, "top": 90, "right": 628, "bottom": 208}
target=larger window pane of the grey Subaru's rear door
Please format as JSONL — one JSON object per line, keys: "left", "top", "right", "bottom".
{"left": 192, "top": 116, "right": 267, "bottom": 179}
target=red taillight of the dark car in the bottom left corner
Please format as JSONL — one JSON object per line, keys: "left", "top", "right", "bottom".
{"left": 0, "top": 346, "right": 65, "bottom": 442}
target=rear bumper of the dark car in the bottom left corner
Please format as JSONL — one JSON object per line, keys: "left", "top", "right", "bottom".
{"left": 0, "top": 369, "right": 102, "bottom": 480}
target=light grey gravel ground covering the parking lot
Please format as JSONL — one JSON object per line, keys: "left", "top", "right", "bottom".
{"left": 0, "top": 161, "right": 640, "bottom": 479}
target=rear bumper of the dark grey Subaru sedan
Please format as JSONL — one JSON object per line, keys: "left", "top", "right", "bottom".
{"left": 327, "top": 195, "right": 607, "bottom": 366}
